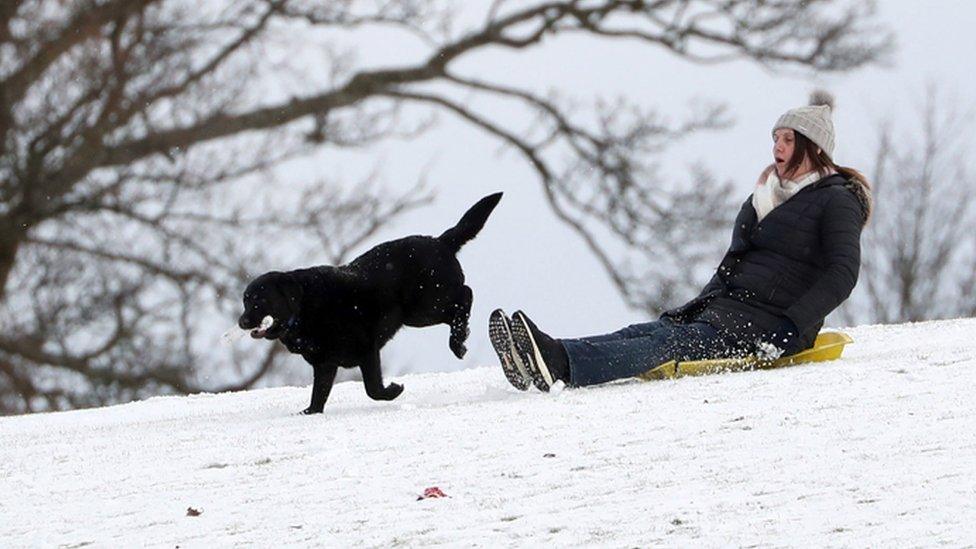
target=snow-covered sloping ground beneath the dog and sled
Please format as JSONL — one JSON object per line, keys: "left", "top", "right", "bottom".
{"left": 0, "top": 319, "right": 976, "bottom": 547}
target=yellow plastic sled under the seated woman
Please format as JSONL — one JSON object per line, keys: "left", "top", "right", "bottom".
{"left": 637, "top": 332, "right": 854, "bottom": 381}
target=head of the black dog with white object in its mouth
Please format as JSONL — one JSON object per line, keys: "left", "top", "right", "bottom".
{"left": 237, "top": 271, "right": 302, "bottom": 339}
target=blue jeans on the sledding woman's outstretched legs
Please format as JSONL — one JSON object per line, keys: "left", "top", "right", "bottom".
{"left": 559, "top": 318, "right": 735, "bottom": 387}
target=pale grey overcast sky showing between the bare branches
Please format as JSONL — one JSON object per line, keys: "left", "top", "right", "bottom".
{"left": 264, "top": 0, "right": 976, "bottom": 378}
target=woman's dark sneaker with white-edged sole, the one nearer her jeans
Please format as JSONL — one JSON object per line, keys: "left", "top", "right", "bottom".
{"left": 511, "top": 311, "right": 569, "bottom": 393}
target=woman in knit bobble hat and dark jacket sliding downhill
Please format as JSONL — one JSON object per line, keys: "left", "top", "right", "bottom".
{"left": 489, "top": 92, "right": 871, "bottom": 391}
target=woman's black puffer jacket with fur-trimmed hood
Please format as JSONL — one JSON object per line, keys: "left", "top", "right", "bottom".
{"left": 662, "top": 174, "right": 870, "bottom": 354}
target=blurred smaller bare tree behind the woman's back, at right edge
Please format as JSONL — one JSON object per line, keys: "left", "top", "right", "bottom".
{"left": 842, "top": 85, "right": 976, "bottom": 324}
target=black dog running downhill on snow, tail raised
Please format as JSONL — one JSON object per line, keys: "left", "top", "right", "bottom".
{"left": 238, "top": 193, "right": 502, "bottom": 414}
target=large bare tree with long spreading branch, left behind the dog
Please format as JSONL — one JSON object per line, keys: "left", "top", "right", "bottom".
{"left": 0, "top": 0, "right": 890, "bottom": 411}
